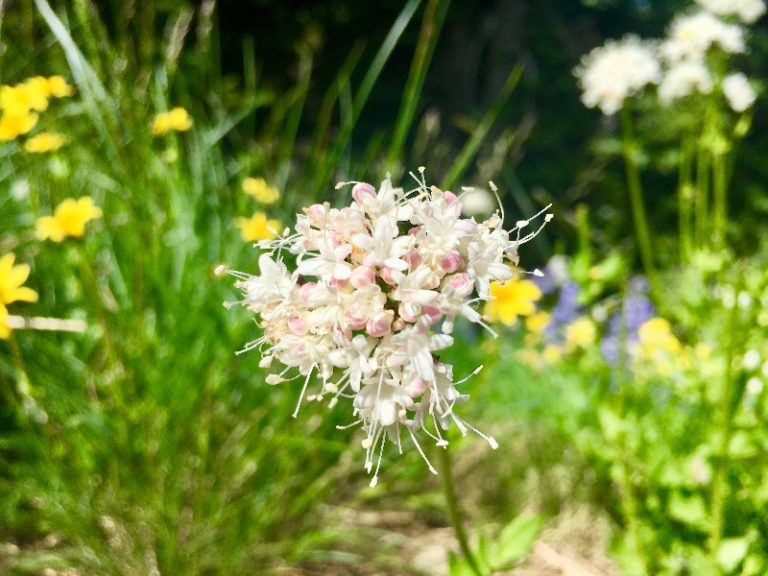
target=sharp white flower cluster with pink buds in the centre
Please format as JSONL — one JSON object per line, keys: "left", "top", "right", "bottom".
{"left": 217, "top": 168, "right": 552, "bottom": 485}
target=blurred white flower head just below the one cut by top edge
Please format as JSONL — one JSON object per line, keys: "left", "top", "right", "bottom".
{"left": 659, "top": 11, "right": 745, "bottom": 62}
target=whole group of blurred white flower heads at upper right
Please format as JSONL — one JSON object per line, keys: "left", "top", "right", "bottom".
{"left": 574, "top": 0, "right": 765, "bottom": 116}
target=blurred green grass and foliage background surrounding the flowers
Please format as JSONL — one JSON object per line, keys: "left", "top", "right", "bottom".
{"left": 0, "top": 0, "right": 768, "bottom": 576}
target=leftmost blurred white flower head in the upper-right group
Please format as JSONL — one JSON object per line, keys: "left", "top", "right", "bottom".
{"left": 574, "top": 35, "right": 661, "bottom": 116}
